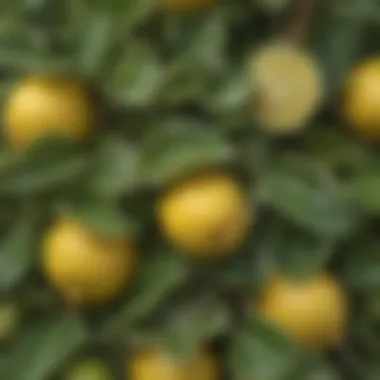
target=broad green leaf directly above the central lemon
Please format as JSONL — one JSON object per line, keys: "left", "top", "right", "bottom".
{"left": 140, "top": 119, "right": 234, "bottom": 185}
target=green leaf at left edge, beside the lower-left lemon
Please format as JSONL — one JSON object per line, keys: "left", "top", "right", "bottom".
{"left": 0, "top": 217, "right": 37, "bottom": 292}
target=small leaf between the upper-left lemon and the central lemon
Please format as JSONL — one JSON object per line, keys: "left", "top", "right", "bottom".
{"left": 89, "top": 136, "right": 140, "bottom": 198}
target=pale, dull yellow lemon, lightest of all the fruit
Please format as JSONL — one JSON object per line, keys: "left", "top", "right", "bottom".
{"left": 250, "top": 42, "right": 324, "bottom": 134}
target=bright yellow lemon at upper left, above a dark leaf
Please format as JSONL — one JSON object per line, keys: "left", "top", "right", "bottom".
{"left": 4, "top": 76, "right": 95, "bottom": 147}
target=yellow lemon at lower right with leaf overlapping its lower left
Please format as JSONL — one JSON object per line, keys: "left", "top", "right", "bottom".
{"left": 258, "top": 273, "right": 348, "bottom": 348}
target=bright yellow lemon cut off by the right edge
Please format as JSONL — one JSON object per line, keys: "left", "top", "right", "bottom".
{"left": 343, "top": 57, "right": 380, "bottom": 140}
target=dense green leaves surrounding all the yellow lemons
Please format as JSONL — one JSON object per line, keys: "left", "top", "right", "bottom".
{"left": 0, "top": 0, "right": 380, "bottom": 380}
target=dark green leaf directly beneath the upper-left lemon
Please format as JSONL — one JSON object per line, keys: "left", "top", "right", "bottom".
{"left": 0, "top": 138, "right": 89, "bottom": 195}
